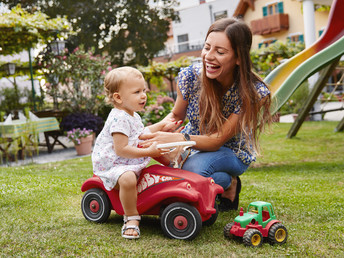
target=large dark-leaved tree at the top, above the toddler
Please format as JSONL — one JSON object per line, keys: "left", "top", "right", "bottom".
{"left": 4, "top": 0, "right": 177, "bottom": 65}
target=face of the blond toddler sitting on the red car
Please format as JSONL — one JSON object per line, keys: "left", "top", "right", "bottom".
{"left": 118, "top": 77, "right": 147, "bottom": 115}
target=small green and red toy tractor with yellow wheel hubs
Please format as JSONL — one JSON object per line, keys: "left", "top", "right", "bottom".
{"left": 223, "top": 201, "right": 288, "bottom": 247}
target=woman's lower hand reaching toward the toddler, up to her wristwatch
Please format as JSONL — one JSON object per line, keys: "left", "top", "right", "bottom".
{"left": 140, "top": 132, "right": 184, "bottom": 148}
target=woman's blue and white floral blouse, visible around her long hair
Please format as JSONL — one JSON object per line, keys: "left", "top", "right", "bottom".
{"left": 178, "top": 64, "right": 270, "bottom": 165}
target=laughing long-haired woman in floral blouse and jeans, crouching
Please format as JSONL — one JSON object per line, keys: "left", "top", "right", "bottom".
{"left": 141, "top": 18, "right": 271, "bottom": 211}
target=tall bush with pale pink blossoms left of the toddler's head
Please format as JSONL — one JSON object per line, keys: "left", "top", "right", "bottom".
{"left": 38, "top": 46, "right": 112, "bottom": 114}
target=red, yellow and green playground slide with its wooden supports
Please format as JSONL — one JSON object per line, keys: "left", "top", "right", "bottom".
{"left": 264, "top": 0, "right": 344, "bottom": 138}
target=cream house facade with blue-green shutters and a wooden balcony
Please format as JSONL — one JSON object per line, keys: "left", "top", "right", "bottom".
{"left": 234, "top": 0, "right": 332, "bottom": 49}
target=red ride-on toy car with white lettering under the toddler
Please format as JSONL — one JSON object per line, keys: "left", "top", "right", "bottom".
{"left": 81, "top": 141, "right": 223, "bottom": 240}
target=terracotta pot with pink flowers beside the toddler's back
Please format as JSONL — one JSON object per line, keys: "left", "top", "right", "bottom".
{"left": 67, "top": 128, "right": 93, "bottom": 156}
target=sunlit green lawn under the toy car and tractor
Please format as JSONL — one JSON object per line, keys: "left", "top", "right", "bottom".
{"left": 0, "top": 122, "right": 344, "bottom": 257}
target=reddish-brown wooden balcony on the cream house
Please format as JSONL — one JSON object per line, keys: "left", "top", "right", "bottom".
{"left": 251, "top": 13, "right": 289, "bottom": 35}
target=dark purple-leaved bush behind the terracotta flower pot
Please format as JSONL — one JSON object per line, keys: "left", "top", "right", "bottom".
{"left": 60, "top": 113, "right": 104, "bottom": 134}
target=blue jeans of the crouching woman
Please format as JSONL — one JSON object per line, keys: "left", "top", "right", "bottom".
{"left": 183, "top": 147, "right": 249, "bottom": 190}
